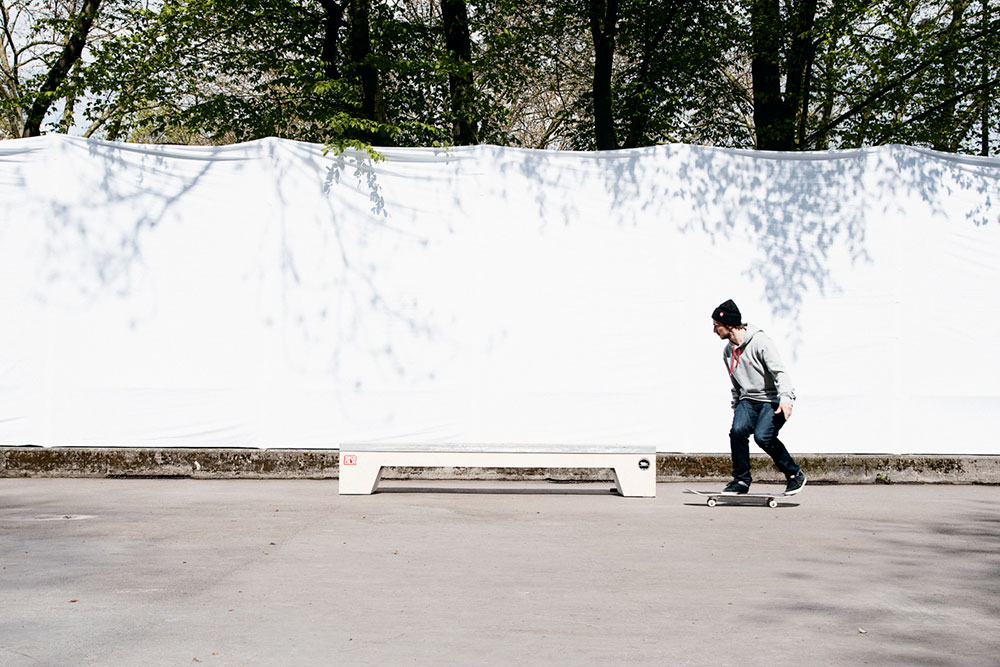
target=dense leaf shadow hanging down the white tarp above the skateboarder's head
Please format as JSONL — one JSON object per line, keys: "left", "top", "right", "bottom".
{"left": 682, "top": 148, "right": 870, "bottom": 328}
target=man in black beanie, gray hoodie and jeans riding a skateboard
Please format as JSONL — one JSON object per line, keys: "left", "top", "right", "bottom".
{"left": 712, "top": 299, "right": 806, "bottom": 496}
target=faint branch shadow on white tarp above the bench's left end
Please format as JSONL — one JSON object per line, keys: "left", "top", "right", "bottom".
{"left": 262, "top": 141, "right": 450, "bottom": 391}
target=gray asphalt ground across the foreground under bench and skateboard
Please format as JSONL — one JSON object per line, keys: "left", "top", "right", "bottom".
{"left": 0, "top": 479, "right": 1000, "bottom": 667}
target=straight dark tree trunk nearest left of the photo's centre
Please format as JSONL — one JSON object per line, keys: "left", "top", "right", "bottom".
{"left": 441, "top": 0, "right": 479, "bottom": 146}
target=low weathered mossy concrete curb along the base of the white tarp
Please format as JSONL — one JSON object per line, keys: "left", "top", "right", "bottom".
{"left": 0, "top": 447, "right": 1000, "bottom": 484}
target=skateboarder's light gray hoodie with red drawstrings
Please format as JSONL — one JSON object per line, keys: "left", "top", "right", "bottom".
{"left": 722, "top": 324, "right": 795, "bottom": 406}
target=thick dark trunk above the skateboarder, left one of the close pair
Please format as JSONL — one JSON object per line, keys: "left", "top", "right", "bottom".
{"left": 750, "top": 0, "right": 795, "bottom": 151}
